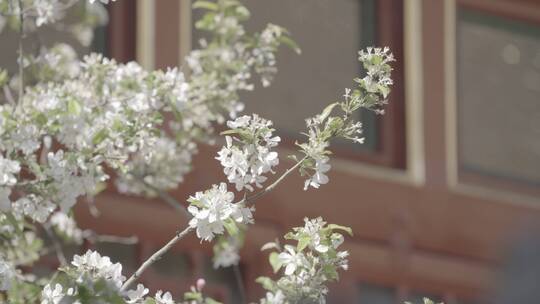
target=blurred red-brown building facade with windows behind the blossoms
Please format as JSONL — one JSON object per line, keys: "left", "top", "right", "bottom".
{"left": 0, "top": 0, "right": 540, "bottom": 304}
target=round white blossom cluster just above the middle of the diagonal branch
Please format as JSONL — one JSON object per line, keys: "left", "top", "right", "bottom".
{"left": 216, "top": 114, "right": 280, "bottom": 191}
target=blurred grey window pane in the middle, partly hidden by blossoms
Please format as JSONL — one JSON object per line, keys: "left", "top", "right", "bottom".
{"left": 193, "top": 0, "right": 377, "bottom": 151}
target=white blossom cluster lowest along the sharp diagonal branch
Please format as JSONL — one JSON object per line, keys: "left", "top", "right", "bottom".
{"left": 188, "top": 183, "right": 253, "bottom": 241}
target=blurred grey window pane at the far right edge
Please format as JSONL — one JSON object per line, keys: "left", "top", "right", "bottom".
{"left": 457, "top": 9, "right": 540, "bottom": 185}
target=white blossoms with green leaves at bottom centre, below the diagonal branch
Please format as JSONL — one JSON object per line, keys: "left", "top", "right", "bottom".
{"left": 257, "top": 218, "right": 351, "bottom": 304}
